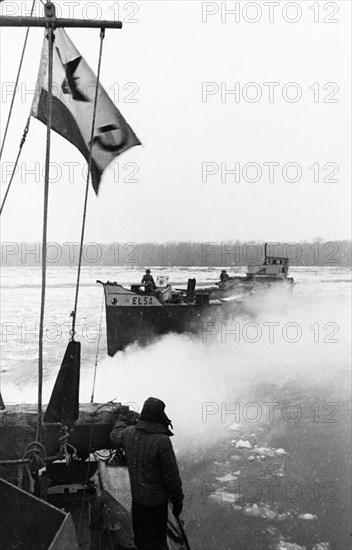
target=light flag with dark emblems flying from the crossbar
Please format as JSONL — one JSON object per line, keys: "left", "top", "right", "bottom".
{"left": 31, "top": 28, "right": 141, "bottom": 193}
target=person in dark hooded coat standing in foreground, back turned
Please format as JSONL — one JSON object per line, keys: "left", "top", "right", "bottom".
{"left": 110, "top": 397, "right": 184, "bottom": 550}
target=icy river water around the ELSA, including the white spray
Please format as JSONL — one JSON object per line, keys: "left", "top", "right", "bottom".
{"left": 1, "top": 266, "right": 351, "bottom": 550}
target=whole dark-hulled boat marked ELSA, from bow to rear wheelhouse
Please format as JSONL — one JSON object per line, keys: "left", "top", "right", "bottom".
{"left": 97, "top": 244, "right": 293, "bottom": 356}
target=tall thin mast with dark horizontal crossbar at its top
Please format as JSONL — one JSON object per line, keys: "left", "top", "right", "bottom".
{"left": 0, "top": 1, "right": 122, "bottom": 442}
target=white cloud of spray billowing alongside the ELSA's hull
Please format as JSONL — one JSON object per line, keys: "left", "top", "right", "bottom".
{"left": 77, "top": 290, "right": 350, "bottom": 452}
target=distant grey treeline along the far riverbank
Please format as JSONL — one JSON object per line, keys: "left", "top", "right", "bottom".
{"left": 1, "top": 239, "right": 351, "bottom": 268}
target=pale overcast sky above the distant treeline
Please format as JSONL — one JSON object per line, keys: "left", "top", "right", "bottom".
{"left": 0, "top": 0, "right": 351, "bottom": 242}
